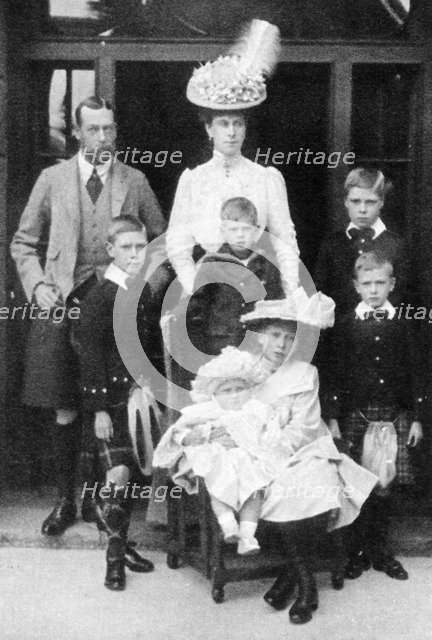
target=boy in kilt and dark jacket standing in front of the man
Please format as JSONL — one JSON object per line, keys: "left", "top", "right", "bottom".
{"left": 74, "top": 216, "right": 157, "bottom": 591}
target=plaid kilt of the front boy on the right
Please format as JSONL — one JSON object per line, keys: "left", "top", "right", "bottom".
{"left": 341, "top": 406, "right": 417, "bottom": 485}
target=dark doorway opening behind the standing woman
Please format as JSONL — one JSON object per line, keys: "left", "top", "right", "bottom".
{"left": 116, "top": 62, "right": 331, "bottom": 276}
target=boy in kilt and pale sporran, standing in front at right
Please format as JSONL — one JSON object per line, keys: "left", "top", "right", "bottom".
{"left": 323, "top": 253, "right": 423, "bottom": 580}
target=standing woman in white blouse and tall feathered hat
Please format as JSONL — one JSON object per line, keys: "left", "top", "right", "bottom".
{"left": 167, "top": 20, "right": 299, "bottom": 295}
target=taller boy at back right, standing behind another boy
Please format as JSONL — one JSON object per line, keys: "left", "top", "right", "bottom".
{"left": 314, "top": 167, "right": 409, "bottom": 317}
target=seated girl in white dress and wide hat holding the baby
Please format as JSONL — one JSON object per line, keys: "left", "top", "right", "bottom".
{"left": 242, "top": 296, "right": 377, "bottom": 624}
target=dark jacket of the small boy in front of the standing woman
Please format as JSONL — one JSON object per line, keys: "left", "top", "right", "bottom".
{"left": 186, "top": 244, "right": 285, "bottom": 355}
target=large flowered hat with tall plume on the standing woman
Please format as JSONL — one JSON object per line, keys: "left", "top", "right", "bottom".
{"left": 186, "top": 20, "right": 279, "bottom": 111}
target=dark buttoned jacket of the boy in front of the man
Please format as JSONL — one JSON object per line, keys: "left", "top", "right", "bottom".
{"left": 73, "top": 280, "right": 148, "bottom": 412}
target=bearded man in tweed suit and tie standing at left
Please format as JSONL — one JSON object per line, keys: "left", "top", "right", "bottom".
{"left": 11, "top": 96, "right": 165, "bottom": 535}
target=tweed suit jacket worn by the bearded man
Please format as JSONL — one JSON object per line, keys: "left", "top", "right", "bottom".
{"left": 11, "top": 155, "right": 165, "bottom": 300}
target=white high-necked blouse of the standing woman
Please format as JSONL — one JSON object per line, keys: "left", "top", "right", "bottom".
{"left": 167, "top": 151, "right": 299, "bottom": 293}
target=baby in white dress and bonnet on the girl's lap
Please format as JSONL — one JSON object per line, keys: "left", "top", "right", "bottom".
{"left": 153, "top": 347, "right": 283, "bottom": 555}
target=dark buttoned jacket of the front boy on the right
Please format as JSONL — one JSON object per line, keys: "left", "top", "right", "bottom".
{"left": 322, "top": 309, "right": 424, "bottom": 418}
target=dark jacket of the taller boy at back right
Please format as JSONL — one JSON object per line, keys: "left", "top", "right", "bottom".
{"left": 314, "top": 229, "right": 410, "bottom": 316}
